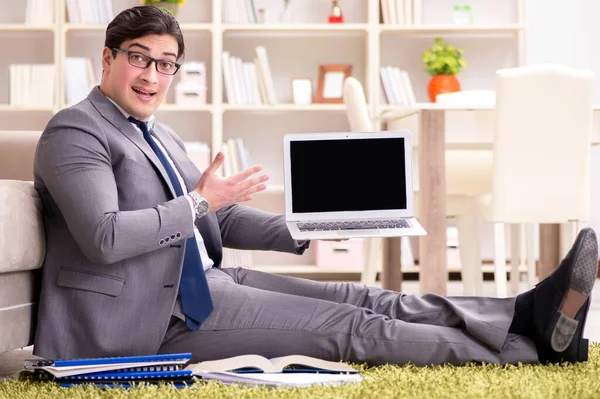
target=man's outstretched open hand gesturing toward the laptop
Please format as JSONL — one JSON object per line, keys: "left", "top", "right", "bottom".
{"left": 194, "top": 151, "right": 269, "bottom": 212}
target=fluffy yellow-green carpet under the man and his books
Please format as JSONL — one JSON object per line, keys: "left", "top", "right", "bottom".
{"left": 0, "top": 343, "right": 600, "bottom": 399}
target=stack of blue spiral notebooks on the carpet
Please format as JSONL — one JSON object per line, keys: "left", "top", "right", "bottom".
{"left": 25, "top": 353, "right": 193, "bottom": 387}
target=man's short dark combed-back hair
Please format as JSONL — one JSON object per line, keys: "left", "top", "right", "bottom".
{"left": 104, "top": 6, "right": 185, "bottom": 59}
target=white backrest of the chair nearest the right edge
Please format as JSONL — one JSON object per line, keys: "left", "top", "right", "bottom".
{"left": 492, "top": 65, "right": 594, "bottom": 223}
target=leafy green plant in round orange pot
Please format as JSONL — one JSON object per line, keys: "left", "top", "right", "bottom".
{"left": 423, "top": 37, "right": 467, "bottom": 102}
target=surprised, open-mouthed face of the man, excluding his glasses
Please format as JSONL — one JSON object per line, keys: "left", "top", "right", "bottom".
{"left": 100, "top": 35, "right": 177, "bottom": 121}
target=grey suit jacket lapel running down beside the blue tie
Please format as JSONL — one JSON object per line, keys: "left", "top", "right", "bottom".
{"left": 88, "top": 87, "right": 177, "bottom": 198}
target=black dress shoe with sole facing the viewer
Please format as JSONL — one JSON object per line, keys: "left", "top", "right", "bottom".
{"left": 533, "top": 228, "right": 598, "bottom": 363}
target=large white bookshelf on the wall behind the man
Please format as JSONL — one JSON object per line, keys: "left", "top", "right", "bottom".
{"left": 0, "top": 0, "right": 526, "bottom": 273}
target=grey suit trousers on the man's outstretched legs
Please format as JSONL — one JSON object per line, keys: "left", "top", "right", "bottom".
{"left": 159, "top": 268, "right": 538, "bottom": 366}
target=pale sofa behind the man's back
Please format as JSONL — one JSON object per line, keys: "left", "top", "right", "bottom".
{"left": 0, "top": 131, "right": 45, "bottom": 352}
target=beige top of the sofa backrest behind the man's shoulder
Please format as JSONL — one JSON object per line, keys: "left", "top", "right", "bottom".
{"left": 0, "top": 131, "right": 41, "bottom": 181}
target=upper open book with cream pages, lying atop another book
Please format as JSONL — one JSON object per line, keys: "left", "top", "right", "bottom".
{"left": 185, "top": 355, "right": 358, "bottom": 374}
